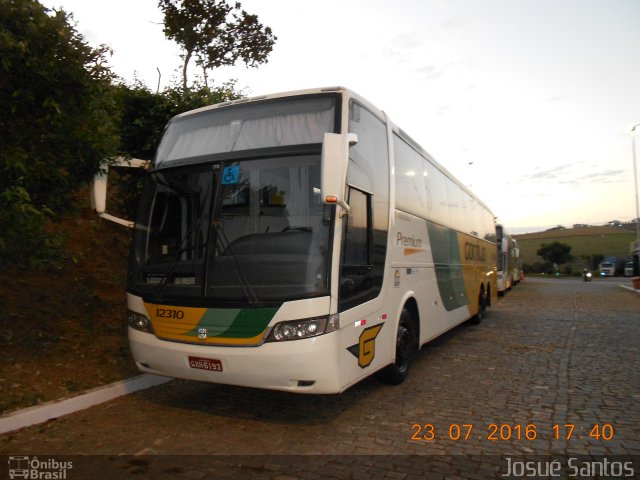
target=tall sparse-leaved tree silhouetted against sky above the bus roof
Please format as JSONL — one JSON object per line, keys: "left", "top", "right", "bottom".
{"left": 158, "top": 0, "right": 277, "bottom": 89}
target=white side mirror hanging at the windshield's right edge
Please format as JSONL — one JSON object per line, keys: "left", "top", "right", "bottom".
{"left": 320, "top": 133, "right": 358, "bottom": 214}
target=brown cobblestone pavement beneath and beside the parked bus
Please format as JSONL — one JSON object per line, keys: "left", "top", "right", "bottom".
{"left": 0, "top": 278, "right": 640, "bottom": 480}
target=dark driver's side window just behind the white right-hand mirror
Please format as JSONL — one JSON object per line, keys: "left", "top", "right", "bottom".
{"left": 340, "top": 187, "right": 376, "bottom": 310}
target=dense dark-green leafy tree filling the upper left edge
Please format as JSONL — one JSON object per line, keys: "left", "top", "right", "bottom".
{"left": 0, "top": 0, "right": 118, "bottom": 266}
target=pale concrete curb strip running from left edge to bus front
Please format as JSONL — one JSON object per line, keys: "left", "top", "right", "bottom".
{"left": 0, "top": 374, "right": 172, "bottom": 434}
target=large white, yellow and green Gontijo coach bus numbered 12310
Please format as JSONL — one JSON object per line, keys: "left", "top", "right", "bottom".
{"left": 96, "top": 87, "right": 497, "bottom": 393}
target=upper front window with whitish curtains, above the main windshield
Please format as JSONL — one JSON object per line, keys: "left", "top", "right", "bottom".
{"left": 155, "top": 96, "right": 336, "bottom": 168}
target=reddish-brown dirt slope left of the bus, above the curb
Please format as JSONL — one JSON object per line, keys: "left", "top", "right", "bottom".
{"left": 0, "top": 196, "right": 137, "bottom": 413}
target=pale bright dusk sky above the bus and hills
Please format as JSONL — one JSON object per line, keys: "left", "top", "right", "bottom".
{"left": 42, "top": 0, "right": 640, "bottom": 233}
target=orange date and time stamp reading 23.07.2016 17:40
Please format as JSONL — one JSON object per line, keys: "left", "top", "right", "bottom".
{"left": 410, "top": 423, "right": 615, "bottom": 443}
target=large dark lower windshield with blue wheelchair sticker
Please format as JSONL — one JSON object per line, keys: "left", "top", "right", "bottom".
{"left": 129, "top": 154, "right": 334, "bottom": 304}
